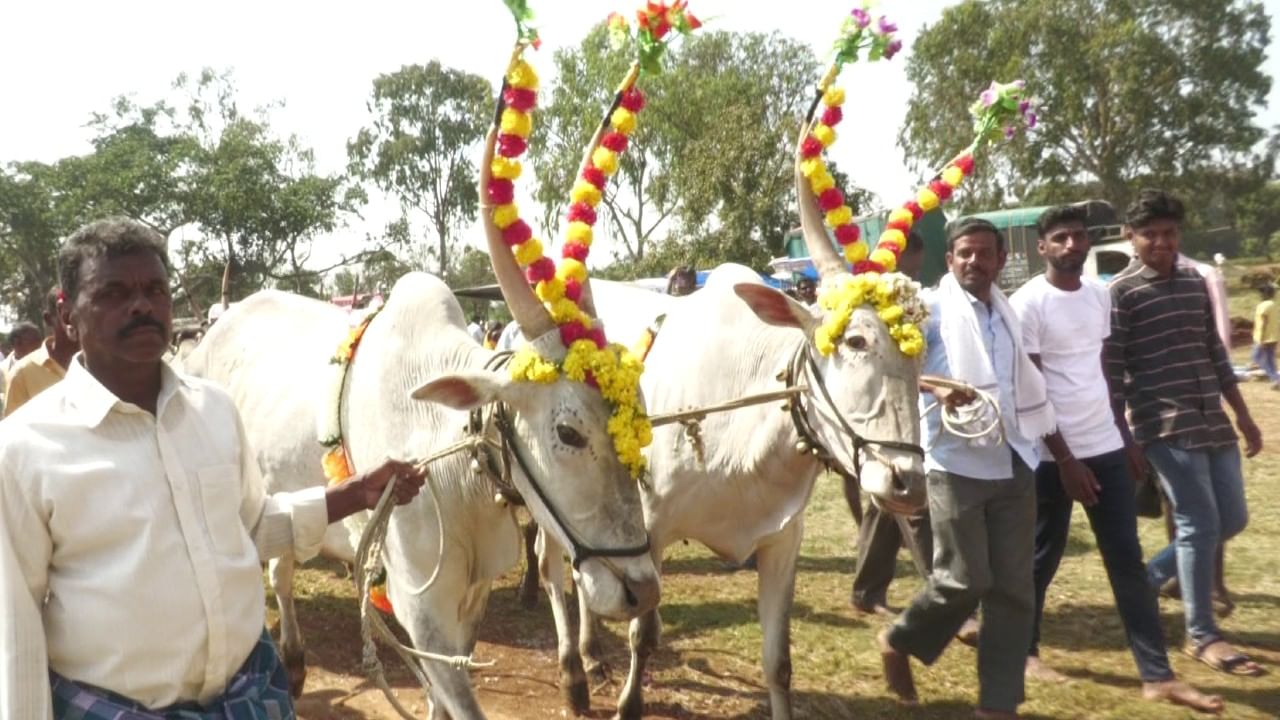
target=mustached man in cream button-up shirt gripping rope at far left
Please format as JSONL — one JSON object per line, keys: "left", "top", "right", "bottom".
{"left": 0, "top": 218, "right": 424, "bottom": 720}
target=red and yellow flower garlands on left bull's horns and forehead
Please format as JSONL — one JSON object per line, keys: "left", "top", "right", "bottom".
{"left": 480, "top": 0, "right": 699, "bottom": 477}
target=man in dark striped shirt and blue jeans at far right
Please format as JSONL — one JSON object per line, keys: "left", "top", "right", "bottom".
{"left": 1103, "top": 190, "right": 1263, "bottom": 675}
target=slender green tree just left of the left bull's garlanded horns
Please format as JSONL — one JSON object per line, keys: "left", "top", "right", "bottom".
{"left": 347, "top": 60, "right": 493, "bottom": 277}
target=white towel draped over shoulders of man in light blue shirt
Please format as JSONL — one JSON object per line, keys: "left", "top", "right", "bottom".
{"left": 938, "top": 273, "right": 1057, "bottom": 441}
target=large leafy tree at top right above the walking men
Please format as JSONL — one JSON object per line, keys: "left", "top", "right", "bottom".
{"left": 899, "top": 0, "right": 1271, "bottom": 208}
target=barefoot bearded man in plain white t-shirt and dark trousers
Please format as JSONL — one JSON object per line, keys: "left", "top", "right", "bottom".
{"left": 1009, "top": 205, "right": 1222, "bottom": 712}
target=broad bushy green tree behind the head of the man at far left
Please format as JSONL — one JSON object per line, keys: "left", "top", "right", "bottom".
{"left": 58, "top": 69, "right": 364, "bottom": 314}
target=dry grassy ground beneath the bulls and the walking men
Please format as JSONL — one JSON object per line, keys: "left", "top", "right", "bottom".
{"left": 277, "top": 371, "right": 1280, "bottom": 720}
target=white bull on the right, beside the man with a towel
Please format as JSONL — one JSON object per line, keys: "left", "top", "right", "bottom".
{"left": 539, "top": 170, "right": 924, "bottom": 720}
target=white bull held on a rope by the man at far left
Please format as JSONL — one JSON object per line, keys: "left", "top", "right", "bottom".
{"left": 187, "top": 196, "right": 659, "bottom": 720}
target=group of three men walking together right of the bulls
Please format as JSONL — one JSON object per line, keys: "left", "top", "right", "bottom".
{"left": 852, "top": 191, "right": 1271, "bottom": 717}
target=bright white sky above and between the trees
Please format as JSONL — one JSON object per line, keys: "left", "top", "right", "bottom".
{"left": 0, "top": 0, "right": 1280, "bottom": 269}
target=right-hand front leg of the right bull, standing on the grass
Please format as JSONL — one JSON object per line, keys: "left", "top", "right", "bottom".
{"left": 758, "top": 514, "right": 804, "bottom": 720}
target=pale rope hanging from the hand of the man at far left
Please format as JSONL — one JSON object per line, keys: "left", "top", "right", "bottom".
{"left": 356, "top": 437, "right": 506, "bottom": 720}
